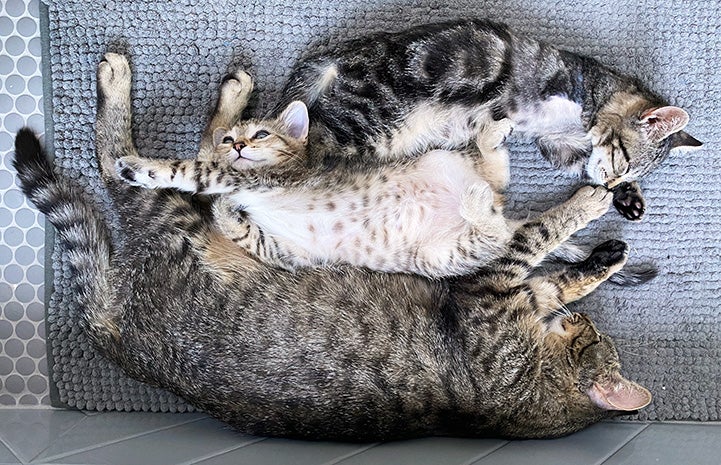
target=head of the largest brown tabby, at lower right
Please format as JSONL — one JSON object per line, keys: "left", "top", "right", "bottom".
{"left": 549, "top": 313, "right": 651, "bottom": 412}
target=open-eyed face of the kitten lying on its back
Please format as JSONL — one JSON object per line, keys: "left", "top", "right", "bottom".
{"left": 213, "top": 102, "right": 308, "bottom": 170}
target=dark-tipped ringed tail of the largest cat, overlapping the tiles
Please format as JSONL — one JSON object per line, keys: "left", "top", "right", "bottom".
{"left": 13, "top": 128, "right": 117, "bottom": 348}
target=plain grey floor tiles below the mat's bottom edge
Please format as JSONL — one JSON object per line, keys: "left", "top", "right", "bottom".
{"left": 0, "top": 409, "right": 721, "bottom": 465}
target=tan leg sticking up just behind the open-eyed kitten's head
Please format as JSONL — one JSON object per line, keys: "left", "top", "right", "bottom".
{"left": 198, "top": 70, "right": 253, "bottom": 160}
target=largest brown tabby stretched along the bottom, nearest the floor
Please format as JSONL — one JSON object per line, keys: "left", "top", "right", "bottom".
{"left": 14, "top": 54, "right": 650, "bottom": 441}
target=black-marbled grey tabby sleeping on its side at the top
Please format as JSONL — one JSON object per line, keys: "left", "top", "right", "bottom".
{"left": 279, "top": 20, "right": 701, "bottom": 220}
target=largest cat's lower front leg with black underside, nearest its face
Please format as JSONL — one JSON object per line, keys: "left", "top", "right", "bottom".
{"left": 529, "top": 240, "right": 629, "bottom": 308}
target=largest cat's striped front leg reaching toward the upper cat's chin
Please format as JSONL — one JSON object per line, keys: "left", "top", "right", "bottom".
{"left": 484, "top": 186, "right": 612, "bottom": 288}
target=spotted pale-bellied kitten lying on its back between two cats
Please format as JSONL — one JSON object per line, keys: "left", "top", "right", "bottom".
{"left": 116, "top": 89, "right": 524, "bottom": 277}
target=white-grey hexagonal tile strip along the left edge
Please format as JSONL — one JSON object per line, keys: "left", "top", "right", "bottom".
{"left": 0, "top": 0, "right": 50, "bottom": 406}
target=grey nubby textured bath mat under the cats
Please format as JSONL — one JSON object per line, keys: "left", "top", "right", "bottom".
{"left": 43, "top": 0, "right": 721, "bottom": 420}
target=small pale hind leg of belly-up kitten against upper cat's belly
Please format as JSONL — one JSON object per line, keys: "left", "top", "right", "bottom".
{"left": 476, "top": 118, "right": 513, "bottom": 196}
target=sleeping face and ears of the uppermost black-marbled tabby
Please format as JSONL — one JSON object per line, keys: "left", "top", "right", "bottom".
{"left": 586, "top": 93, "right": 701, "bottom": 188}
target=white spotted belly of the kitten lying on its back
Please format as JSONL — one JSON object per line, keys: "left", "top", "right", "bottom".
{"left": 236, "top": 150, "right": 511, "bottom": 276}
